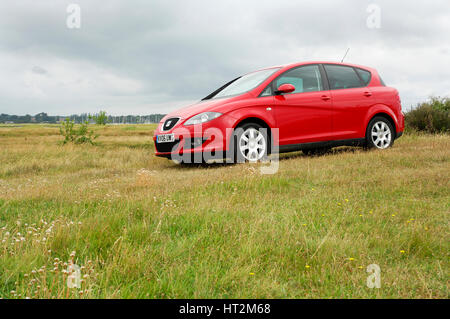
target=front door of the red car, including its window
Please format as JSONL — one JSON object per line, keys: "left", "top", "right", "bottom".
{"left": 273, "top": 64, "right": 332, "bottom": 145}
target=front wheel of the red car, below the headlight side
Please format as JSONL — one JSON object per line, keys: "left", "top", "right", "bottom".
{"left": 233, "top": 123, "right": 270, "bottom": 163}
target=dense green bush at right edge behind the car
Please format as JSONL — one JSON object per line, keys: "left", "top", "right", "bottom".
{"left": 405, "top": 97, "right": 450, "bottom": 133}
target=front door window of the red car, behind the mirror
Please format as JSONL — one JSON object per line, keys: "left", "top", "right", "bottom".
{"left": 275, "top": 65, "right": 323, "bottom": 94}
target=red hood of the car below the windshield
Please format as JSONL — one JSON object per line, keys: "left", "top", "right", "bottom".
{"left": 161, "top": 93, "right": 247, "bottom": 122}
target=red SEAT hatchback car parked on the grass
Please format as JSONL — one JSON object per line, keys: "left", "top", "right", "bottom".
{"left": 153, "top": 62, "right": 404, "bottom": 162}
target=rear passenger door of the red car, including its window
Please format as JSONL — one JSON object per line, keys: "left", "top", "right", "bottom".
{"left": 323, "top": 64, "right": 376, "bottom": 140}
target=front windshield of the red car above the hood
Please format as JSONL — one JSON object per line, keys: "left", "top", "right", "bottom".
{"left": 205, "top": 68, "right": 279, "bottom": 99}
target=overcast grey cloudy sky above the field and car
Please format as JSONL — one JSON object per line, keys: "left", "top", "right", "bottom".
{"left": 0, "top": 0, "right": 450, "bottom": 115}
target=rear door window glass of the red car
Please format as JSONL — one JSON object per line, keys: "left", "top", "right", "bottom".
{"left": 324, "top": 64, "right": 364, "bottom": 90}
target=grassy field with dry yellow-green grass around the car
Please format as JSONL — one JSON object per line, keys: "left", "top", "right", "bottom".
{"left": 0, "top": 125, "right": 450, "bottom": 298}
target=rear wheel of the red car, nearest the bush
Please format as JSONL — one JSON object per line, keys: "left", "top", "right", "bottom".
{"left": 366, "top": 116, "right": 395, "bottom": 149}
